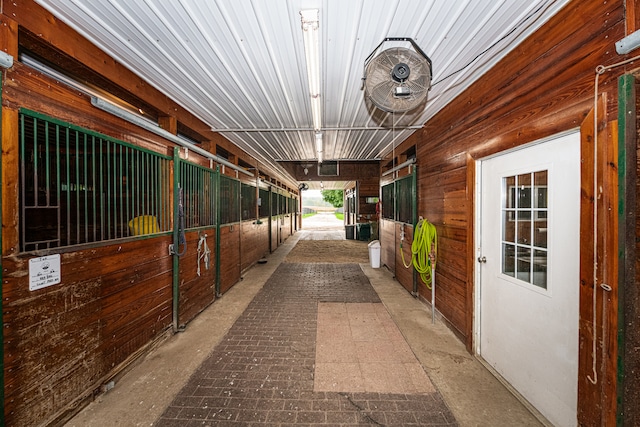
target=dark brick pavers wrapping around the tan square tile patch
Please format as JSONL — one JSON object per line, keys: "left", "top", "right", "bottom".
{"left": 156, "top": 263, "right": 457, "bottom": 427}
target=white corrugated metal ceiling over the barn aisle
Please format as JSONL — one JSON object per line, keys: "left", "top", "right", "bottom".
{"left": 37, "top": 0, "right": 568, "bottom": 181}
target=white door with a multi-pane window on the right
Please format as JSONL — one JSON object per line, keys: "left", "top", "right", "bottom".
{"left": 476, "top": 132, "right": 580, "bottom": 426}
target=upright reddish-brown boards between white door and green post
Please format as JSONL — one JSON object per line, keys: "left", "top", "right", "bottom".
{"left": 578, "top": 95, "right": 618, "bottom": 425}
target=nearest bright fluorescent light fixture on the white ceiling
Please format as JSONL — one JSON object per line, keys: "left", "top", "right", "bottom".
{"left": 300, "top": 9, "right": 322, "bottom": 131}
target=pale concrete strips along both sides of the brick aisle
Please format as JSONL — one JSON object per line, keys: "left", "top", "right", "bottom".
{"left": 67, "top": 216, "right": 542, "bottom": 427}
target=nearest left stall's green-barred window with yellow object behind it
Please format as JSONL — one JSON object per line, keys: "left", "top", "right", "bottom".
{"left": 19, "top": 110, "right": 171, "bottom": 251}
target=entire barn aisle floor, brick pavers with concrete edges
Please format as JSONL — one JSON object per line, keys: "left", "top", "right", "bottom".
{"left": 67, "top": 218, "right": 540, "bottom": 427}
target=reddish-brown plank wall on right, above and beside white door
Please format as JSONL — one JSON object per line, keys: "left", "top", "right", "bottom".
{"left": 382, "top": 0, "right": 634, "bottom": 425}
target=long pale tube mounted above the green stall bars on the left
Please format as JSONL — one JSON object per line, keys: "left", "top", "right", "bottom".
{"left": 91, "top": 96, "right": 254, "bottom": 177}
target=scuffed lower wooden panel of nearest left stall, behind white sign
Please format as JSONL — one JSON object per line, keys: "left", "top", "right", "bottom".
{"left": 2, "top": 239, "right": 172, "bottom": 425}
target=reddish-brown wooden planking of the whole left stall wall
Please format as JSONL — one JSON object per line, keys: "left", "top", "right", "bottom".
{"left": 0, "top": 0, "right": 298, "bottom": 426}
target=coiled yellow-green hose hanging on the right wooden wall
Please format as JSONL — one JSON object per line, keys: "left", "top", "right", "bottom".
{"left": 400, "top": 218, "right": 438, "bottom": 289}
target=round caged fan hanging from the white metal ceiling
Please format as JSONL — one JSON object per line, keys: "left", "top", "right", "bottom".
{"left": 362, "top": 37, "right": 432, "bottom": 113}
